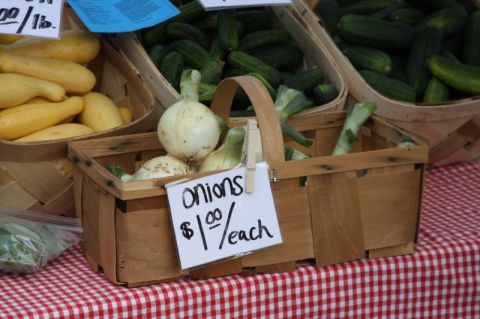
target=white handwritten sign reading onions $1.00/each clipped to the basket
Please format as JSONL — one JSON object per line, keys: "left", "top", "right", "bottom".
{"left": 167, "top": 163, "right": 282, "bottom": 270}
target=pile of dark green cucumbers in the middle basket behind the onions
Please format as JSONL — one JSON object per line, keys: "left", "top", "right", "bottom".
{"left": 137, "top": 1, "right": 338, "bottom": 110}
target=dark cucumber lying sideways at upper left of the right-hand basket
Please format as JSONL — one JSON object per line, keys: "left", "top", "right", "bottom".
{"left": 337, "top": 14, "right": 415, "bottom": 49}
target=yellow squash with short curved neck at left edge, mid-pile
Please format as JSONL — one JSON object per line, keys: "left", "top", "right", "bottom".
{"left": 0, "top": 73, "right": 65, "bottom": 109}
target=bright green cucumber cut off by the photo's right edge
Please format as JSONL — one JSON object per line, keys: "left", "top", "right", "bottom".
{"left": 427, "top": 55, "right": 480, "bottom": 94}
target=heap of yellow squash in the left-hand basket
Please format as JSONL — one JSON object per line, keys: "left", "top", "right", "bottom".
{"left": 0, "top": 30, "right": 132, "bottom": 142}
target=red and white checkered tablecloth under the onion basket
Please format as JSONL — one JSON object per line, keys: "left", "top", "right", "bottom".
{"left": 0, "top": 163, "right": 480, "bottom": 319}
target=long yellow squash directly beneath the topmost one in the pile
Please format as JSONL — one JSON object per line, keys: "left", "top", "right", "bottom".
{"left": 0, "top": 53, "right": 96, "bottom": 94}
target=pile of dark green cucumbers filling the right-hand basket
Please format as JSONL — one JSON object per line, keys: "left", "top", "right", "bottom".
{"left": 314, "top": 0, "right": 480, "bottom": 103}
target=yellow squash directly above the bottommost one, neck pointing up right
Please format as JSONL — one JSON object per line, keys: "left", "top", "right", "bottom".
{"left": 0, "top": 96, "right": 84, "bottom": 140}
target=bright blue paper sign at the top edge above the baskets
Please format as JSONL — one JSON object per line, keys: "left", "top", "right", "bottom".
{"left": 68, "top": 0, "right": 180, "bottom": 33}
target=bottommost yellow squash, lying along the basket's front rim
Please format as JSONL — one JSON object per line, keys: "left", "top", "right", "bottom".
{"left": 15, "top": 123, "right": 94, "bottom": 142}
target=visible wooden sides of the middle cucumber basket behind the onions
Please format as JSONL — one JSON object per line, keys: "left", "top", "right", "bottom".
{"left": 112, "top": 7, "right": 348, "bottom": 114}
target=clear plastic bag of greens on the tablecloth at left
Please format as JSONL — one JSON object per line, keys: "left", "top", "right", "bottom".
{"left": 0, "top": 208, "right": 82, "bottom": 274}
